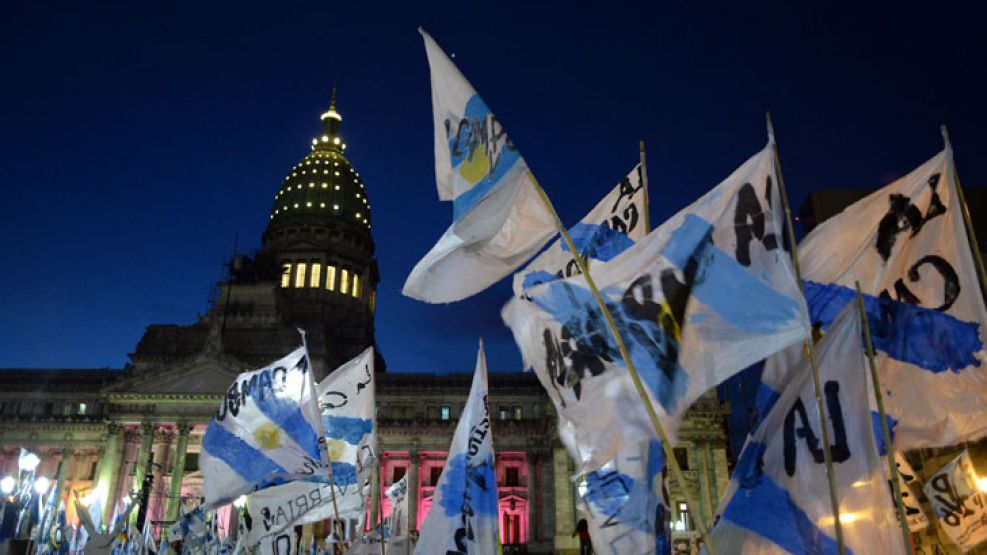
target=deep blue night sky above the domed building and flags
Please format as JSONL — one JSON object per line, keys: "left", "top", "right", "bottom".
{"left": 0, "top": 2, "right": 987, "bottom": 372}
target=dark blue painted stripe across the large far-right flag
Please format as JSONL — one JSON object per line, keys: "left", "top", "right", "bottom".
{"left": 805, "top": 280, "right": 984, "bottom": 373}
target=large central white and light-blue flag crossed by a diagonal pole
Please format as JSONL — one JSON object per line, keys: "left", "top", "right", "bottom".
{"left": 502, "top": 146, "right": 808, "bottom": 471}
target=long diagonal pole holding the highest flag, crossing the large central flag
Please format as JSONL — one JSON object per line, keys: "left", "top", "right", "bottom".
{"left": 528, "top": 175, "right": 716, "bottom": 555}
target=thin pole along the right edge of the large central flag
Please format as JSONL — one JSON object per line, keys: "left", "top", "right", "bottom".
{"left": 765, "top": 112, "right": 846, "bottom": 555}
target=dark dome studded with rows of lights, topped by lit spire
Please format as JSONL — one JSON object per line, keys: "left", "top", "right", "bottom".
{"left": 268, "top": 90, "right": 370, "bottom": 233}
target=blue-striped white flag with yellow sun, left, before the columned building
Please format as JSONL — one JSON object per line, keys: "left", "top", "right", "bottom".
{"left": 200, "top": 347, "right": 328, "bottom": 510}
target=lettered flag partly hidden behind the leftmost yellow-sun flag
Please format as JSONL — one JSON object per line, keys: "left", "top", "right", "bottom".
{"left": 246, "top": 347, "right": 377, "bottom": 546}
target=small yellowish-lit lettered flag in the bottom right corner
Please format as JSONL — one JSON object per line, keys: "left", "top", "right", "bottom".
{"left": 924, "top": 449, "right": 987, "bottom": 553}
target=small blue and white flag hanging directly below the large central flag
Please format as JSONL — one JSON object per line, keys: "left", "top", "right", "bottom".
{"left": 578, "top": 440, "right": 669, "bottom": 555}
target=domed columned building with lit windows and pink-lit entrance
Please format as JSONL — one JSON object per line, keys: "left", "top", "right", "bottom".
{"left": 0, "top": 93, "right": 729, "bottom": 553}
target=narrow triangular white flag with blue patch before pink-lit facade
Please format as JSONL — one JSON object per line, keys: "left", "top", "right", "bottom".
{"left": 415, "top": 341, "right": 500, "bottom": 555}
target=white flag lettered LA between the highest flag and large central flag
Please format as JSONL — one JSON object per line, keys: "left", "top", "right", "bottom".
{"left": 514, "top": 164, "right": 648, "bottom": 297}
